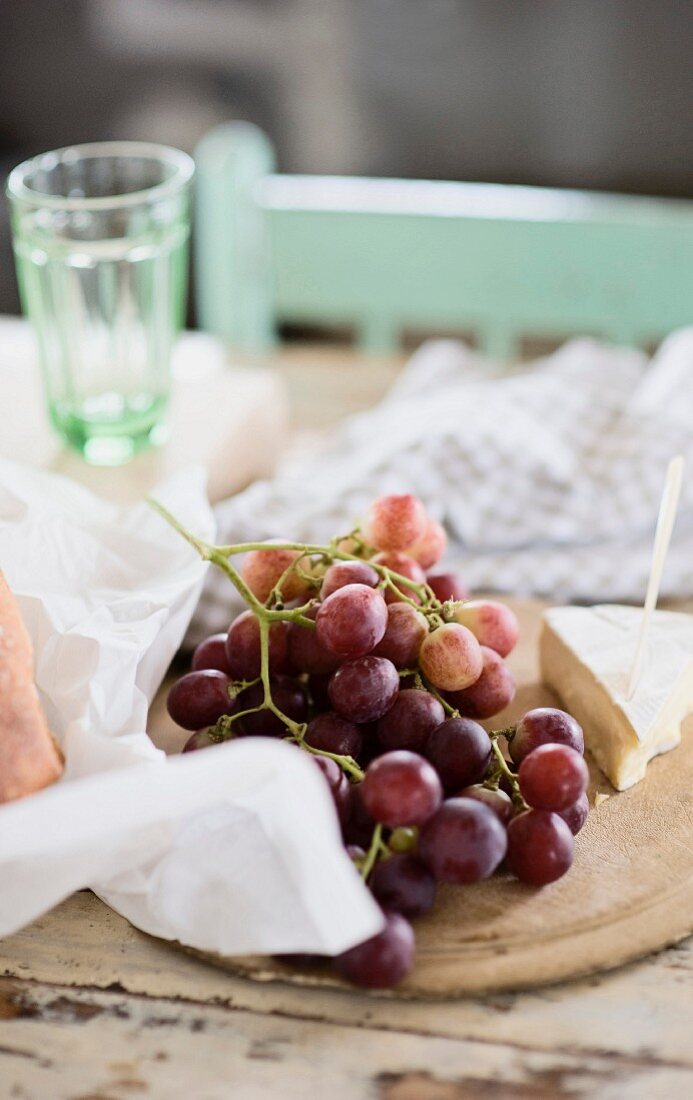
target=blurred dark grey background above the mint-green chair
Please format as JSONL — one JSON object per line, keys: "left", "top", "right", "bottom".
{"left": 0, "top": 0, "right": 693, "bottom": 312}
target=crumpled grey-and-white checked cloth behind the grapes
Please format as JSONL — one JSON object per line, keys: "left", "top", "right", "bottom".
{"left": 188, "top": 329, "right": 693, "bottom": 642}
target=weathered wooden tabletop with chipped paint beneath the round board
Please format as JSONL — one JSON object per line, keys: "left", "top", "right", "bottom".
{"left": 0, "top": 338, "right": 693, "bottom": 1100}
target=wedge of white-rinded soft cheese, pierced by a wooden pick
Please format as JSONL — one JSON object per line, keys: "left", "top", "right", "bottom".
{"left": 539, "top": 604, "right": 693, "bottom": 791}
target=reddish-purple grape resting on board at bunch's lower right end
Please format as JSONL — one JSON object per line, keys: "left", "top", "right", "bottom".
{"left": 507, "top": 810, "right": 575, "bottom": 887}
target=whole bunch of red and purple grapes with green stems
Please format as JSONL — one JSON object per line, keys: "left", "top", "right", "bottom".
{"left": 168, "top": 494, "right": 589, "bottom": 988}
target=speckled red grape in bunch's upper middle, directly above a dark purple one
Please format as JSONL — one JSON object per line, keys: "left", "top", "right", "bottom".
{"left": 316, "top": 584, "right": 387, "bottom": 660}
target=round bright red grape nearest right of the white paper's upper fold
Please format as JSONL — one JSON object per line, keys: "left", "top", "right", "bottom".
{"left": 362, "top": 750, "right": 442, "bottom": 828}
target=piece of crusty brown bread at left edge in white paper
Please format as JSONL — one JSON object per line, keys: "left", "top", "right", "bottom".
{"left": 0, "top": 571, "right": 63, "bottom": 803}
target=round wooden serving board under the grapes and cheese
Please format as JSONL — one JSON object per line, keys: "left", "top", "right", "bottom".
{"left": 152, "top": 602, "right": 693, "bottom": 998}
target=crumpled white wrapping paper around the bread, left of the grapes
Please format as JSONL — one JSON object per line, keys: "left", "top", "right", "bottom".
{"left": 0, "top": 462, "right": 382, "bottom": 954}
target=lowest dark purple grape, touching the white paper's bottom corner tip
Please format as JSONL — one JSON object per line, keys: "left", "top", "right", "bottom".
{"left": 337, "top": 913, "right": 415, "bottom": 989}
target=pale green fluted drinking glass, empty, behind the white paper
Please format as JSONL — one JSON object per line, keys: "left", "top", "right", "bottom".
{"left": 7, "top": 142, "right": 195, "bottom": 465}
